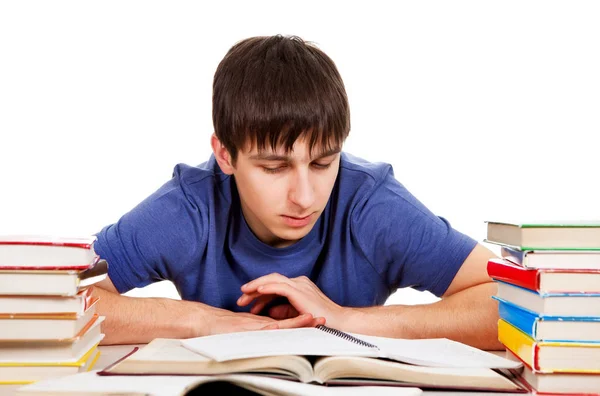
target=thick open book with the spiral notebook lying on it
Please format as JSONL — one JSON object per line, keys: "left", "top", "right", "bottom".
{"left": 99, "top": 326, "right": 522, "bottom": 392}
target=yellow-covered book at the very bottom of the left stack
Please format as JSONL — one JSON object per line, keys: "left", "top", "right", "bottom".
{"left": 0, "top": 345, "right": 100, "bottom": 385}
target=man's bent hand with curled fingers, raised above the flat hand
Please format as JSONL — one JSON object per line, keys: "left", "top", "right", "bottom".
{"left": 237, "top": 273, "right": 346, "bottom": 327}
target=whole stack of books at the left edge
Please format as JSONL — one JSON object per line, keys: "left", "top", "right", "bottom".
{"left": 0, "top": 236, "right": 107, "bottom": 386}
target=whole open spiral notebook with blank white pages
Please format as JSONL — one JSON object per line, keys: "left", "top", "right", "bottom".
{"left": 182, "top": 326, "right": 520, "bottom": 369}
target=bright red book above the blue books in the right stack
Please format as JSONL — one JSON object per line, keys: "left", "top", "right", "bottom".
{"left": 487, "top": 258, "right": 600, "bottom": 294}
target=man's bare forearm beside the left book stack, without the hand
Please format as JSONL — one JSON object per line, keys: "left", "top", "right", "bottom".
{"left": 93, "top": 287, "right": 208, "bottom": 345}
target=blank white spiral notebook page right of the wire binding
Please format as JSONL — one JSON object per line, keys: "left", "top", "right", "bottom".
{"left": 353, "top": 334, "right": 522, "bottom": 369}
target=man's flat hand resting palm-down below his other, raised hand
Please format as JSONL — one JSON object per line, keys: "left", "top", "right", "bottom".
{"left": 204, "top": 307, "right": 322, "bottom": 335}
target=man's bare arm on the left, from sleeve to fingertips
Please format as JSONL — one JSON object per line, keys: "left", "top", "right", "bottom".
{"left": 93, "top": 278, "right": 325, "bottom": 345}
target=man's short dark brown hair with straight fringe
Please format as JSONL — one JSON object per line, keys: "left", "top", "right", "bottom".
{"left": 213, "top": 35, "right": 350, "bottom": 163}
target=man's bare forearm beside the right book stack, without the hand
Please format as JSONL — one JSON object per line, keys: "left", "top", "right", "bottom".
{"left": 341, "top": 283, "right": 504, "bottom": 350}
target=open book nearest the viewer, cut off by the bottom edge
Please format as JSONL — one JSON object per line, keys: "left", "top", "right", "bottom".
{"left": 16, "top": 372, "right": 422, "bottom": 396}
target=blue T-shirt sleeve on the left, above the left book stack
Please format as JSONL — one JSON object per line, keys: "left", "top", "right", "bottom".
{"left": 94, "top": 167, "right": 204, "bottom": 293}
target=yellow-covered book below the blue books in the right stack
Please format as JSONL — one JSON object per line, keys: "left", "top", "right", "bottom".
{"left": 498, "top": 319, "right": 600, "bottom": 373}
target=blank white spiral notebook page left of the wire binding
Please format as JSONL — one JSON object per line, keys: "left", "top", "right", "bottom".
{"left": 181, "top": 328, "right": 379, "bottom": 362}
